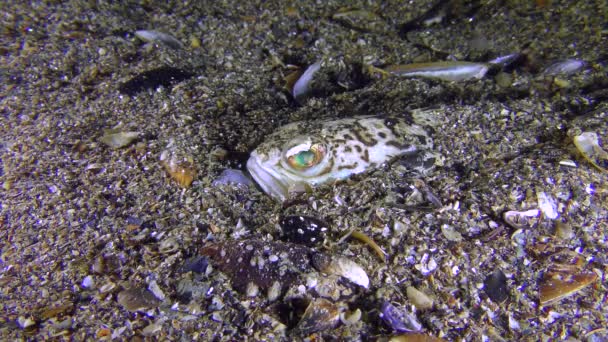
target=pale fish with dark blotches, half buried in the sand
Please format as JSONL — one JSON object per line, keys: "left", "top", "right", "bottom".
{"left": 247, "top": 112, "right": 435, "bottom": 201}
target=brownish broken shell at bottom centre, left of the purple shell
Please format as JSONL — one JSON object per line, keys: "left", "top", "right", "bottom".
{"left": 294, "top": 298, "right": 340, "bottom": 335}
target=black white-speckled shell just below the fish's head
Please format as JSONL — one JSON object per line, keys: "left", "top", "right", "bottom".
{"left": 279, "top": 215, "right": 329, "bottom": 247}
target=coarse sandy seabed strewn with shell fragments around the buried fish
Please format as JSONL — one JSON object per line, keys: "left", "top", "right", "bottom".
{"left": 0, "top": 0, "right": 608, "bottom": 341}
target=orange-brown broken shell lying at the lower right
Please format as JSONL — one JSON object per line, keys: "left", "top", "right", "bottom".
{"left": 539, "top": 271, "right": 597, "bottom": 306}
